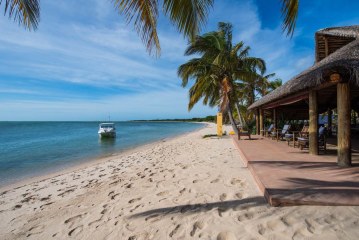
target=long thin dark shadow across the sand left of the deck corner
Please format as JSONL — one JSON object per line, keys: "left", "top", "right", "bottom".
{"left": 130, "top": 197, "right": 267, "bottom": 220}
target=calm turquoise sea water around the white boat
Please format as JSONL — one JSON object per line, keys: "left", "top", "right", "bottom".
{"left": 0, "top": 122, "right": 203, "bottom": 185}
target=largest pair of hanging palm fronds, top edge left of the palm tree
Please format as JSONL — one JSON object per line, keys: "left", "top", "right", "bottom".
{"left": 112, "top": 0, "right": 214, "bottom": 56}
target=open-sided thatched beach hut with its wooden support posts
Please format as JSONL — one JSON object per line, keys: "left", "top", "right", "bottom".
{"left": 249, "top": 26, "right": 359, "bottom": 166}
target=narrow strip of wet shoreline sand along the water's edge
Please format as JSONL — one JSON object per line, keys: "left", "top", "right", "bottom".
{"left": 0, "top": 122, "right": 213, "bottom": 193}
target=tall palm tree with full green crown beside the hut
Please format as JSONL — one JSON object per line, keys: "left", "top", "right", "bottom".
{"left": 178, "top": 23, "right": 265, "bottom": 134}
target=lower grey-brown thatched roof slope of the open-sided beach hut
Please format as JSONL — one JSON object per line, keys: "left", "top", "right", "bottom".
{"left": 249, "top": 38, "right": 359, "bottom": 109}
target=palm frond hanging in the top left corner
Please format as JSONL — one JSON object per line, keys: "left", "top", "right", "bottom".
{"left": 0, "top": 0, "right": 40, "bottom": 30}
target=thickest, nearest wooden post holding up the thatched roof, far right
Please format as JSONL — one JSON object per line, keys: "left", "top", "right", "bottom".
{"left": 337, "top": 83, "right": 351, "bottom": 167}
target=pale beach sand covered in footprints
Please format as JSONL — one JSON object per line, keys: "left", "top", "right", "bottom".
{"left": 0, "top": 124, "right": 359, "bottom": 240}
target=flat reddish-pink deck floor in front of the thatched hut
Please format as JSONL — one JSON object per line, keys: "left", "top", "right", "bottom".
{"left": 233, "top": 135, "right": 359, "bottom": 206}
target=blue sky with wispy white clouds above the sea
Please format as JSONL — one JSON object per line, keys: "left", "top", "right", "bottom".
{"left": 0, "top": 0, "right": 359, "bottom": 121}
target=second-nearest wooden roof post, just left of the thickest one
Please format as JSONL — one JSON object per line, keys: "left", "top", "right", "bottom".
{"left": 309, "top": 90, "right": 319, "bottom": 155}
